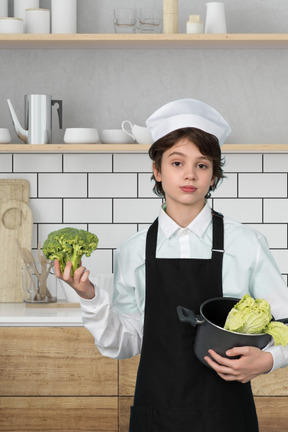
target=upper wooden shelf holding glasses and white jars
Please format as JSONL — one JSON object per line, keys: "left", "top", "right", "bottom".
{"left": 0, "top": 33, "right": 288, "bottom": 49}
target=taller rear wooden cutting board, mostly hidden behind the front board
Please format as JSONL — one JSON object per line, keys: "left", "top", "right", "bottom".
{"left": 0, "top": 179, "right": 30, "bottom": 229}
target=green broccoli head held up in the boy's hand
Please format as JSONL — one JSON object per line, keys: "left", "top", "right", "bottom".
{"left": 43, "top": 227, "right": 98, "bottom": 276}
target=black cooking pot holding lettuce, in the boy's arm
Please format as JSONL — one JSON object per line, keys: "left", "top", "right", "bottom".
{"left": 177, "top": 297, "right": 288, "bottom": 366}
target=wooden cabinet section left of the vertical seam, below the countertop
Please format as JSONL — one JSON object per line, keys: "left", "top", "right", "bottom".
{"left": 0, "top": 327, "right": 119, "bottom": 432}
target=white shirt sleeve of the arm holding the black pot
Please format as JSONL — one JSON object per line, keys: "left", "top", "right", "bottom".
{"left": 252, "top": 231, "right": 288, "bottom": 371}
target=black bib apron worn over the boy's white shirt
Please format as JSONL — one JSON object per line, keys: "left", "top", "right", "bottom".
{"left": 129, "top": 211, "right": 258, "bottom": 432}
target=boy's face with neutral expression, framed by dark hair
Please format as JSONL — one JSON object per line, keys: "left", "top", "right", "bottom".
{"left": 153, "top": 138, "right": 214, "bottom": 220}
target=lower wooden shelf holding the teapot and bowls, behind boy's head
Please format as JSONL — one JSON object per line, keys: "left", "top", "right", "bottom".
{"left": 0, "top": 144, "right": 288, "bottom": 153}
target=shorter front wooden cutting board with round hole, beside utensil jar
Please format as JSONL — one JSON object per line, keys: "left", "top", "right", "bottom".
{"left": 0, "top": 200, "right": 33, "bottom": 303}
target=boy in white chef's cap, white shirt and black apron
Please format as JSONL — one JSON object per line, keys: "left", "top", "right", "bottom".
{"left": 55, "top": 99, "right": 288, "bottom": 432}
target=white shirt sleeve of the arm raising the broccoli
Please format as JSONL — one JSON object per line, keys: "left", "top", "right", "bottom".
{"left": 80, "top": 231, "right": 145, "bottom": 359}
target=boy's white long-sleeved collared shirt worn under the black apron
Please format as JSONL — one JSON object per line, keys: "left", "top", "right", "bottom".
{"left": 81, "top": 204, "right": 288, "bottom": 370}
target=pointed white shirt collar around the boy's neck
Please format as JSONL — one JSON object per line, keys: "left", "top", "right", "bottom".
{"left": 159, "top": 203, "right": 212, "bottom": 238}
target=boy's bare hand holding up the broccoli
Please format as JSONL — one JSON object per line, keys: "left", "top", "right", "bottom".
{"left": 54, "top": 260, "right": 95, "bottom": 300}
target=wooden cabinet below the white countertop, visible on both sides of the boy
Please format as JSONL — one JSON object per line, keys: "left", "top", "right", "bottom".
{"left": 0, "top": 327, "right": 288, "bottom": 432}
